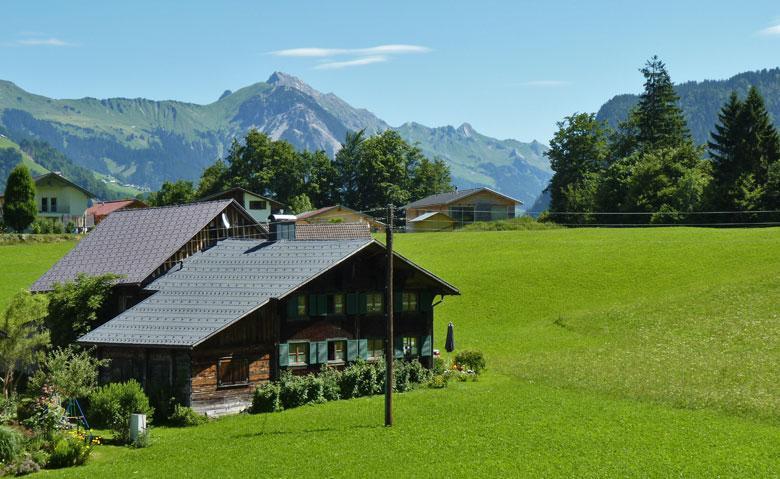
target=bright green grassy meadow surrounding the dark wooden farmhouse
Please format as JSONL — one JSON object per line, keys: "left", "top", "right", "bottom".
{"left": 0, "top": 228, "right": 780, "bottom": 477}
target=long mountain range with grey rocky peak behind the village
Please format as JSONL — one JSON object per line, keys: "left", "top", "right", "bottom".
{"left": 0, "top": 72, "right": 551, "bottom": 203}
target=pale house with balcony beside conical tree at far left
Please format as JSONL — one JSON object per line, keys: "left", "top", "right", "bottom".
{"left": 0, "top": 172, "right": 95, "bottom": 228}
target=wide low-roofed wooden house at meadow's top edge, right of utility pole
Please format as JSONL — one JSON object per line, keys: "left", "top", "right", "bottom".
{"left": 403, "top": 187, "right": 523, "bottom": 231}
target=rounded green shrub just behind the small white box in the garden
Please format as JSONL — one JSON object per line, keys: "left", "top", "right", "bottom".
{"left": 89, "top": 379, "right": 154, "bottom": 442}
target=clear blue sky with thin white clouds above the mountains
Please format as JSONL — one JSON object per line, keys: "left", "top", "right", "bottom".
{"left": 0, "top": 0, "right": 780, "bottom": 142}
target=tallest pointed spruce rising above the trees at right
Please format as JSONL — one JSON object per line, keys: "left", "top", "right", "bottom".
{"left": 634, "top": 56, "right": 692, "bottom": 150}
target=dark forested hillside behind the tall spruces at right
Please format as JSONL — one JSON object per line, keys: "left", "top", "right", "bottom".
{"left": 597, "top": 68, "right": 780, "bottom": 144}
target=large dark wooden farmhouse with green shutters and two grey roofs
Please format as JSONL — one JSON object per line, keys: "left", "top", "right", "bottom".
{"left": 33, "top": 200, "right": 459, "bottom": 415}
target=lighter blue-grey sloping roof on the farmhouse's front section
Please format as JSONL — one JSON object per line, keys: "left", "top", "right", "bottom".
{"left": 79, "top": 239, "right": 373, "bottom": 347}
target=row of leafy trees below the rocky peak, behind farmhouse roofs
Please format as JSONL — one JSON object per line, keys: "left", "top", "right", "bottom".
{"left": 148, "top": 129, "right": 453, "bottom": 213}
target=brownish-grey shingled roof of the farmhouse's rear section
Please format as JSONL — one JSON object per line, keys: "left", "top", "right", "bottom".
{"left": 30, "top": 200, "right": 265, "bottom": 291}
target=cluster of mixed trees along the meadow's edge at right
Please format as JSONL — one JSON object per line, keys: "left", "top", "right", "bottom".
{"left": 547, "top": 57, "right": 780, "bottom": 224}
